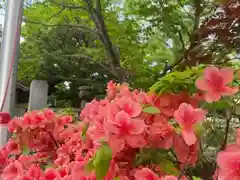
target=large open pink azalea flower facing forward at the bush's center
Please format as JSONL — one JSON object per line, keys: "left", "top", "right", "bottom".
{"left": 105, "top": 111, "right": 146, "bottom": 152}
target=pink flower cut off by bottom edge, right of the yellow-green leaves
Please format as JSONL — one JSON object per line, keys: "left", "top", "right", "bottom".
{"left": 134, "top": 168, "right": 160, "bottom": 180}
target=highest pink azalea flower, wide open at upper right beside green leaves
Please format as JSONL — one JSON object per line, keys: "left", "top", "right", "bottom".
{"left": 196, "top": 67, "right": 238, "bottom": 102}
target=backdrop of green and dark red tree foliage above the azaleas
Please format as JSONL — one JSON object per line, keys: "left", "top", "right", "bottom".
{"left": 0, "top": 0, "right": 237, "bottom": 107}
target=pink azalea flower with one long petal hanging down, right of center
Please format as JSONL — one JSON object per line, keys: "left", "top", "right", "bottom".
{"left": 174, "top": 103, "right": 206, "bottom": 146}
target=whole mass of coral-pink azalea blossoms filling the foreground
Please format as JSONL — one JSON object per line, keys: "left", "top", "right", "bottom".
{"left": 0, "top": 67, "right": 240, "bottom": 180}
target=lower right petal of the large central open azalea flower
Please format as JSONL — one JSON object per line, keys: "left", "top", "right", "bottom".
{"left": 125, "top": 135, "right": 146, "bottom": 148}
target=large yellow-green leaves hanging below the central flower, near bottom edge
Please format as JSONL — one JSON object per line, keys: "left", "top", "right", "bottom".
{"left": 86, "top": 144, "right": 112, "bottom": 180}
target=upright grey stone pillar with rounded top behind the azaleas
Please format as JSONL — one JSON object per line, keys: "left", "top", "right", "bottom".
{"left": 28, "top": 80, "right": 48, "bottom": 111}
